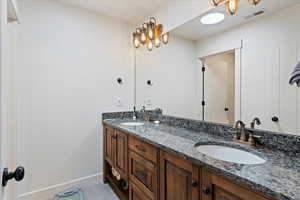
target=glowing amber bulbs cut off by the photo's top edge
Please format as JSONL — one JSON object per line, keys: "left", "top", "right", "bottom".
{"left": 210, "top": 0, "right": 261, "bottom": 15}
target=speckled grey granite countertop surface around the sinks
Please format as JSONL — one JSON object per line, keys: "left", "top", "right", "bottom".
{"left": 103, "top": 119, "right": 300, "bottom": 200}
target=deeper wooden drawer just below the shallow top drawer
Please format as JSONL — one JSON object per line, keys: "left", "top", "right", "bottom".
{"left": 129, "top": 151, "right": 158, "bottom": 199}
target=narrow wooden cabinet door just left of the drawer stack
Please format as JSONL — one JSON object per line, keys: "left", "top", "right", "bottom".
{"left": 115, "top": 130, "right": 128, "bottom": 179}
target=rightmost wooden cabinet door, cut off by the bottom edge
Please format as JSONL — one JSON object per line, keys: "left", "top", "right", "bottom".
{"left": 202, "top": 170, "right": 268, "bottom": 200}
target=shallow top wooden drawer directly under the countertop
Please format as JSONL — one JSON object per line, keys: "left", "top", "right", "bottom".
{"left": 129, "top": 137, "right": 158, "bottom": 163}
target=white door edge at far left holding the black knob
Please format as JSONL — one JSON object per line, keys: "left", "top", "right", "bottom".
{"left": 0, "top": 0, "right": 17, "bottom": 200}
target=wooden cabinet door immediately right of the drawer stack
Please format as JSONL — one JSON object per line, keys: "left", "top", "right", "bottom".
{"left": 160, "top": 151, "right": 199, "bottom": 200}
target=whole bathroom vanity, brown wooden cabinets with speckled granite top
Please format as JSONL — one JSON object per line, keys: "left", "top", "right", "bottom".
{"left": 103, "top": 112, "right": 300, "bottom": 200}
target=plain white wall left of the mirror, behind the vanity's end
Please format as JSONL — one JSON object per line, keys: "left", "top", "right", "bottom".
{"left": 10, "top": 0, "right": 134, "bottom": 199}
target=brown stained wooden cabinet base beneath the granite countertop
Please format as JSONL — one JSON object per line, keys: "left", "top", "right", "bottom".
{"left": 103, "top": 126, "right": 270, "bottom": 200}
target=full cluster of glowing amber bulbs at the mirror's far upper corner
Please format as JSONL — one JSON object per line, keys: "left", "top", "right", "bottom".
{"left": 133, "top": 17, "right": 169, "bottom": 51}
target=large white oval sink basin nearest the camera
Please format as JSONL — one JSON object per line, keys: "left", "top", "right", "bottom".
{"left": 196, "top": 145, "right": 266, "bottom": 165}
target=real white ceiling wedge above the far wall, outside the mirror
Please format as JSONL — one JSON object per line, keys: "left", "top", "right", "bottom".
{"left": 56, "top": 0, "right": 167, "bottom": 23}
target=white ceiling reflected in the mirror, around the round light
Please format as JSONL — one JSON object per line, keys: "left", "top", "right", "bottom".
{"left": 172, "top": 0, "right": 300, "bottom": 40}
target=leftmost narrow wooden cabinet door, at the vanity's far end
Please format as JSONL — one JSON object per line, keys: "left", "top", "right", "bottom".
{"left": 104, "top": 126, "right": 116, "bottom": 166}
